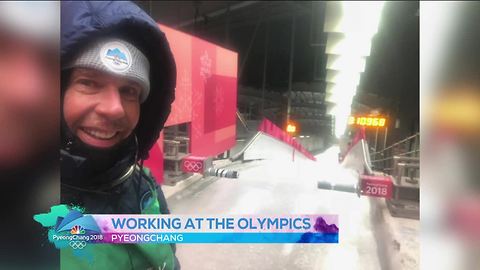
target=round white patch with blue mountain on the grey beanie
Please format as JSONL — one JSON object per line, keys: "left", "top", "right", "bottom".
{"left": 100, "top": 42, "right": 132, "bottom": 72}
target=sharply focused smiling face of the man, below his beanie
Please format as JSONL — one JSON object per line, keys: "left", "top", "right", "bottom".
{"left": 63, "top": 68, "right": 142, "bottom": 148}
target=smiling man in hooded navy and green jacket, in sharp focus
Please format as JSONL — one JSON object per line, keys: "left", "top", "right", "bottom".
{"left": 61, "top": 2, "right": 179, "bottom": 269}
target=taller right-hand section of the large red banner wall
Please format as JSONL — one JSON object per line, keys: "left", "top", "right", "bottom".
{"left": 191, "top": 31, "right": 237, "bottom": 156}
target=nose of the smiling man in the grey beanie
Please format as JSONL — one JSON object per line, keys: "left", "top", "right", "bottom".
{"left": 96, "top": 85, "right": 125, "bottom": 120}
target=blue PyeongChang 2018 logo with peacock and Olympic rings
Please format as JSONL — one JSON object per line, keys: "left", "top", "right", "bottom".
{"left": 52, "top": 210, "right": 103, "bottom": 249}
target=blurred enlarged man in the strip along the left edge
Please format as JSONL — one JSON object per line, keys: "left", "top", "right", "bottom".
{"left": 0, "top": 1, "right": 60, "bottom": 269}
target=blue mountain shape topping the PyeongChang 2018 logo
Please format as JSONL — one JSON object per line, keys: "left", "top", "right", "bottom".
{"left": 55, "top": 210, "right": 101, "bottom": 233}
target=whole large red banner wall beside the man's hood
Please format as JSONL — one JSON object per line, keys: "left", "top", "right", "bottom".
{"left": 145, "top": 24, "right": 238, "bottom": 183}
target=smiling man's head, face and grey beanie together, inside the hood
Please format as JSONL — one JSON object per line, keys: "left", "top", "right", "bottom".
{"left": 64, "top": 40, "right": 150, "bottom": 151}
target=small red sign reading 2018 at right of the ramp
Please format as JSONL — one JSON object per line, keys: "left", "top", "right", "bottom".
{"left": 360, "top": 175, "right": 393, "bottom": 199}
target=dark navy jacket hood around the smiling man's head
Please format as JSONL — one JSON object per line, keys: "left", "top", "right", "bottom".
{"left": 60, "top": 1, "right": 176, "bottom": 159}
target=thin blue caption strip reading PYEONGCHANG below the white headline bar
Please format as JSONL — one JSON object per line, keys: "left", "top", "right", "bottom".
{"left": 102, "top": 232, "right": 338, "bottom": 244}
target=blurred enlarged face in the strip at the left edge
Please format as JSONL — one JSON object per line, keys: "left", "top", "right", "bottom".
{"left": 0, "top": 29, "right": 60, "bottom": 170}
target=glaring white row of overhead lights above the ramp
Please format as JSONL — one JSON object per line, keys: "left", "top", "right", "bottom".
{"left": 324, "top": 1, "right": 384, "bottom": 137}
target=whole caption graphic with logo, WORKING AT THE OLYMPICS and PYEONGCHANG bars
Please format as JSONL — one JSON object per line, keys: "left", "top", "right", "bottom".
{"left": 34, "top": 208, "right": 339, "bottom": 249}
